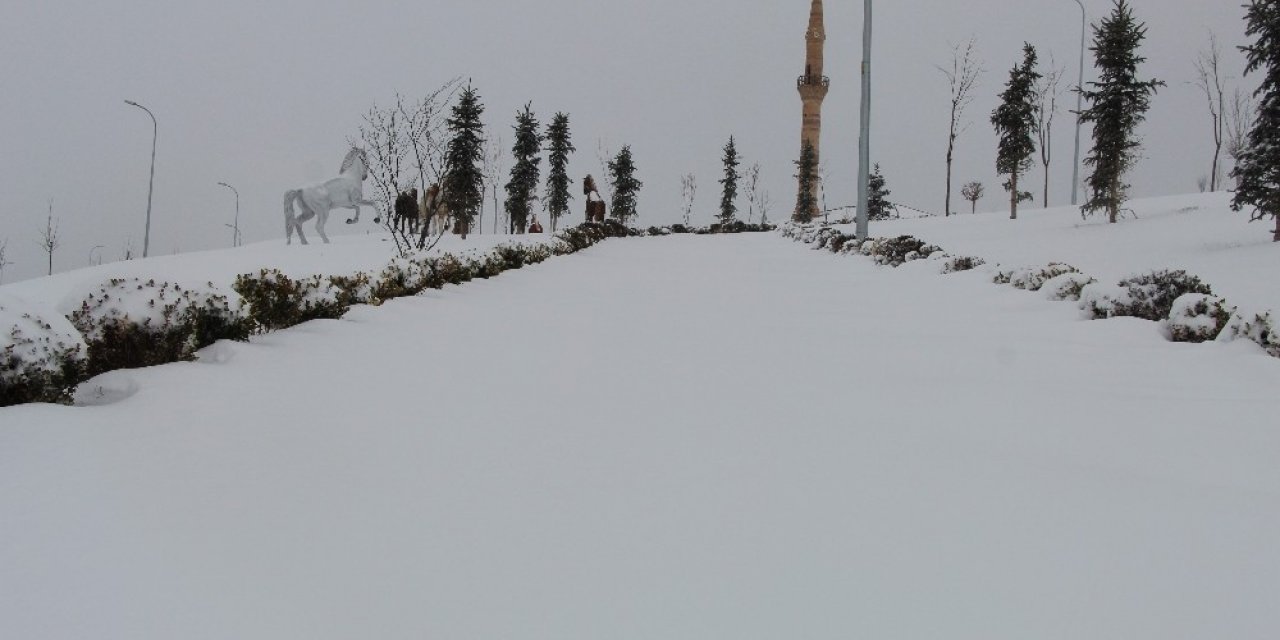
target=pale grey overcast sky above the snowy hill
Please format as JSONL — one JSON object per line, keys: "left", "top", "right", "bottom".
{"left": 0, "top": 0, "right": 1256, "bottom": 282}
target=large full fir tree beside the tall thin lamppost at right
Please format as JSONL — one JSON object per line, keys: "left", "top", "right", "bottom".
{"left": 1080, "top": 0, "right": 1165, "bottom": 223}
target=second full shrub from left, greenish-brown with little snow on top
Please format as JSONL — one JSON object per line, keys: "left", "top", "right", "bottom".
{"left": 233, "top": 269, "right": 352, "bottom": 332}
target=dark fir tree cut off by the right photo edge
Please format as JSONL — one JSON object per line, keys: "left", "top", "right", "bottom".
{"left": 1231, "top": 0, "right": 1280, "bottom": 242}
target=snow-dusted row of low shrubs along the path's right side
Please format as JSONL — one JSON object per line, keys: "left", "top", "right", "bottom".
{"left": 782, "top": 224, "right": 1280, "bottom": 357}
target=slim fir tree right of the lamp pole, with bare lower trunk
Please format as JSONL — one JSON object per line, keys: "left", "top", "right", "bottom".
{"left": 991, "top": 42, "right": 1041, "bottom": 220}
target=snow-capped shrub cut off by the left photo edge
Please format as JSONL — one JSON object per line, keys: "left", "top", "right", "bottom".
{"left": 0, "top": 298, "right": 86, "bottom": 407}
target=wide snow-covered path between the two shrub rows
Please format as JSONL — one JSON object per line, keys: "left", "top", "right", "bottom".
{"left": 0, "top": 234, "right": 1280, "bottom": 640}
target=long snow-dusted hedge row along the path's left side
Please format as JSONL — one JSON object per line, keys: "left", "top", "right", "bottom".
{"left": 0, "top": 220, "right": 774, "bottom": 406}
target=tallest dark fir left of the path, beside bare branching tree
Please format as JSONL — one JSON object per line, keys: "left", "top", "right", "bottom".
{"left": 435, "top": 84, "right": 484, "bottom": 246}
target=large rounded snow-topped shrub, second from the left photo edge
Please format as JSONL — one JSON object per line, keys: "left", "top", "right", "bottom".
{"left": 69, "top": 278, "right": 253, "bottom": 376}
